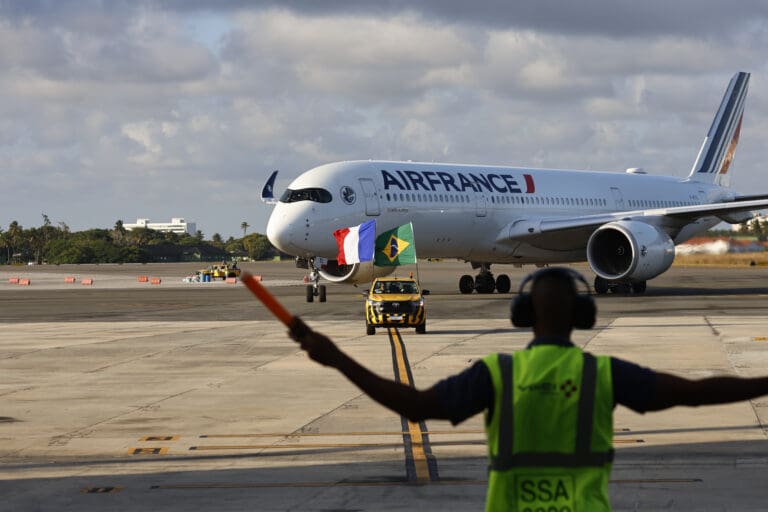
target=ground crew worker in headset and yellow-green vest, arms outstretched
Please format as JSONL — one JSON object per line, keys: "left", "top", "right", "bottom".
{"left": 290, "top": 267, "right": 768, "bottom": 512}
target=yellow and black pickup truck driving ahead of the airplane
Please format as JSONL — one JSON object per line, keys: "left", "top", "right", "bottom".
{"left": 365, "top": 277, "right": 429, "bottom": 335}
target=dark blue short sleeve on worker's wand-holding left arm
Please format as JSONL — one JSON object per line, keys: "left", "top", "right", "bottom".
{"left": 434, "top": 361, "right": 493, "bottom": 425}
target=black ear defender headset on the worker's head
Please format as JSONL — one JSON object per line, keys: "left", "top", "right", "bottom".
{"left": 512, "top": 267, "right": 597, "bottom": 329}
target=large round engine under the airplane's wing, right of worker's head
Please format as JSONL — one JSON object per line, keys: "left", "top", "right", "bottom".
{"left": 587, "top": 220, "right": 675, "bottom": 281}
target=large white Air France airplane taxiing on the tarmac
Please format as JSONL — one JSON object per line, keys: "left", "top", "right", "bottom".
{"left": 262, "top": 72, "right": 768, "bottom": 301}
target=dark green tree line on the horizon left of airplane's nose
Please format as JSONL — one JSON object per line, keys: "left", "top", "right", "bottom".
{"left": 0, "top": 214, "right": 278, "bottom": 264}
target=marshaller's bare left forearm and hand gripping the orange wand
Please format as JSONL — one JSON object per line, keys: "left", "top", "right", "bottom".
{"left": 289, "top": 317, "right": 447, "bottom": 421}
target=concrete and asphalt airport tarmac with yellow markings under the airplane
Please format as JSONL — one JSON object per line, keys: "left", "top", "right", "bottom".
{"left": 0, "top": 262, "right": 768, "bottom": 511}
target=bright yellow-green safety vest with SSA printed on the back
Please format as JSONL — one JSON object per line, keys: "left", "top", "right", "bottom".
{"left": 483, "top": 345, "right": 613, "bottom": 512}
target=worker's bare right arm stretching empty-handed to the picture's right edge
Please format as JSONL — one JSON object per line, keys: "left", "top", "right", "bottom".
{"left": 648, "top": 373, "right": 768, "bottom": 411}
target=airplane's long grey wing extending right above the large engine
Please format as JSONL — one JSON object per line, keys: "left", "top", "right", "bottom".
{"left": 496, "top": 196, "right": 768, "bottom": 242}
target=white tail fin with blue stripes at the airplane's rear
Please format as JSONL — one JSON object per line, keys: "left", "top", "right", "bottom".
{"left": 688, "top": 71, "right": 749, "bottom": 187}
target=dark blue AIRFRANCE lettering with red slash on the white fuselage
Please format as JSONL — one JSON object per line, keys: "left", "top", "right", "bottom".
{"left": 381, "top": 169, "right": 536, "bottom": 194}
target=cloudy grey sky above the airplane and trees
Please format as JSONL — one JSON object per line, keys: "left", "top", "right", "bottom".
{"left": 0, "top": 0, "right": 768, "bottom": 238}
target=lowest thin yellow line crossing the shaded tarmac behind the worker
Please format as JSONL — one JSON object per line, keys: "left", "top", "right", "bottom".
{"left": 150, "top": 478, "right": 703, "bottom": 490}
